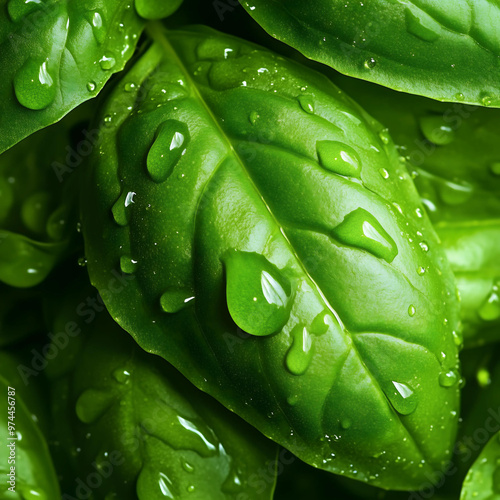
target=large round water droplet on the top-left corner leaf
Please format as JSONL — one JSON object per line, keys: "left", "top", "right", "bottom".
{"left": 14, "top": 58, "right": 56, "bottom": 110}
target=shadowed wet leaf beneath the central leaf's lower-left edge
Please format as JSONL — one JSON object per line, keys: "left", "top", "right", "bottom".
{"left": 50, "top": 302, "right": 277, "bottom": 500}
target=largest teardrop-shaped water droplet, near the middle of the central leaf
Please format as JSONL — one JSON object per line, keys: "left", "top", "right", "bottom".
{"left": 224, "top": 252, "right": 291, "bottom": 336}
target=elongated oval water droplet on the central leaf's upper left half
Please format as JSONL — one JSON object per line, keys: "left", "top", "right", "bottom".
{"left": 147, "top": 120, "right": 190, "bottom": 183}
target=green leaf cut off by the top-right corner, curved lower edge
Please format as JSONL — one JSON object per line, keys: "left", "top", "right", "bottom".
{"left": 240, "top": 0, "right": 500, "bottom": 107}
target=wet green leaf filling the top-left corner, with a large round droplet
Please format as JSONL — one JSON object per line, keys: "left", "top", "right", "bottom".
{"left": 0, "top": 0, "right": 144, "bottom": 152}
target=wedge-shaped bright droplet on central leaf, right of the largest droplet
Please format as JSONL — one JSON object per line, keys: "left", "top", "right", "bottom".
{"left": 333, "top": 208, "right": 398, "bottom": 262}
